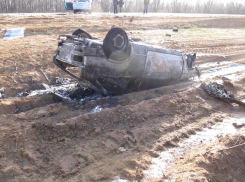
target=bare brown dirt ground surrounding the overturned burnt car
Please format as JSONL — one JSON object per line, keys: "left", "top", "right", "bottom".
{"left": 0, "top": 14, "right": 245, "bottom": 182}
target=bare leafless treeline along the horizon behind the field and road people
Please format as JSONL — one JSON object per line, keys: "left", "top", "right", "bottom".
{"left": 0, "top": 0, "right": 245, "bottom": 14}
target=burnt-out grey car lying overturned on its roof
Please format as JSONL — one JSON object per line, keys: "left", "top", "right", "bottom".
{"left": 53, "top": 27, "right": 196, "bottom": 95}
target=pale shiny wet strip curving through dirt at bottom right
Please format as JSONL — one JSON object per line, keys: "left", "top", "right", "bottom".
{"left": 142, "top": 118, "right": 245, "bottom": 182}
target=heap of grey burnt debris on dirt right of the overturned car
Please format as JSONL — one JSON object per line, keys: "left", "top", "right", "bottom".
{"left": 200, "top": 82, "right": 245, "bottom": 107}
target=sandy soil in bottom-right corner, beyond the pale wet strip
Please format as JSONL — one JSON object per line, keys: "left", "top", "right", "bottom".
{"left": 167, "top": 130, "right": 245, "bottom": 182}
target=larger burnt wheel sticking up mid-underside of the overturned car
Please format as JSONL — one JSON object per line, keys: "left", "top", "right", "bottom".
{"left": 103, "top": 27, "right": 130, "bottom": 61}
